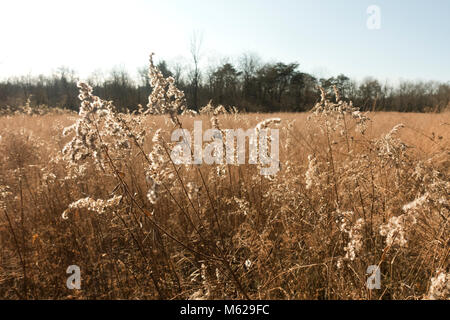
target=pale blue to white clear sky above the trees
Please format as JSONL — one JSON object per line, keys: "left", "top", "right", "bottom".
{"left": 0, "top": 0, "right": 450, "bottom": 82}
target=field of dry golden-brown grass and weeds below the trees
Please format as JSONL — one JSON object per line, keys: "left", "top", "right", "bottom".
{"left": 0, "top": 58, "right": 450, "bottom": 299}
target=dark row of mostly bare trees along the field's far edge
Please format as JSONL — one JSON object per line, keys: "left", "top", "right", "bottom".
{"left": 0, "top": 54, "right": 450, "bottom": 112}
